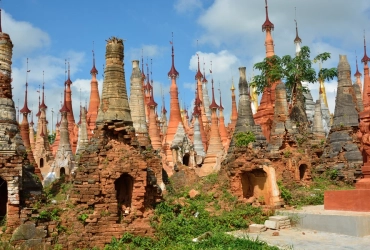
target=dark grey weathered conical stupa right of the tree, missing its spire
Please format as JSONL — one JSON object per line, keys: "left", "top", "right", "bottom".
{"left": 318, "top": 55, "right": 362, "bottom": 181}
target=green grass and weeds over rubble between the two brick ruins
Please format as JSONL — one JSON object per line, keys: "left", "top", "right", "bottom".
{"left": 105, "top": 175, "right": 278, "bottom": 250}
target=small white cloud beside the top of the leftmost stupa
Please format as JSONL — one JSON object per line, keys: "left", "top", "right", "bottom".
{"left": 1, "top": 10, "right": 51, "bottom": 58}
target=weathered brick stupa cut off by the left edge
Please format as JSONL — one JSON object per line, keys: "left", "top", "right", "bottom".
{"left": 0, "top": 9, "right": 42, "bottom": 233}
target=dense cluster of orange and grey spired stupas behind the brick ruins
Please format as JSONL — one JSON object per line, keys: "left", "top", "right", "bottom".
{"left": 11, "top": 2, "right": 370, "bottom": 186}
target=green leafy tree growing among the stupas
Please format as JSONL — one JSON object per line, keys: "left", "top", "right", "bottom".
{"left": 251, "top": 46, "right": 337, "bottom": 122}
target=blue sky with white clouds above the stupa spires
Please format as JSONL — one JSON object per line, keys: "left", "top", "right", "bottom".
{"left": 1, "top": 0, "right": 370, "bottom": 131}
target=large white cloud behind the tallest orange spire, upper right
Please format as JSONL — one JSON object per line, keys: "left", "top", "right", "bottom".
{"left": 192, "top": 0, "right": 369, "bottom": 115}
